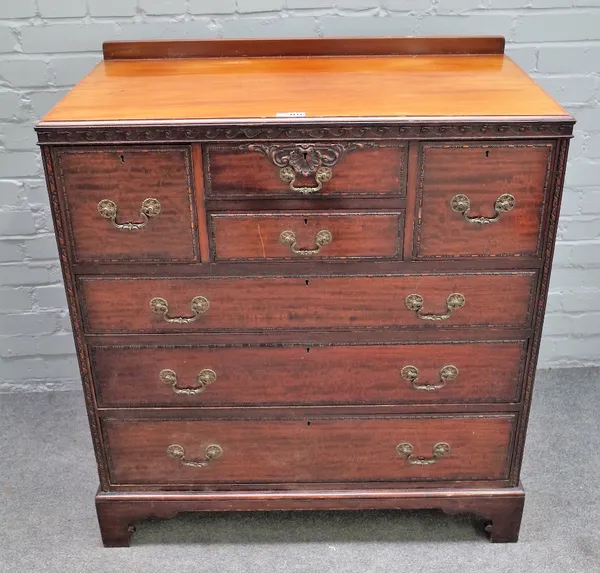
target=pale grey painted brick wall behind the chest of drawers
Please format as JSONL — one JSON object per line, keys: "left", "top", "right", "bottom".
{"left": 0, "top": 0, "right": 600, "bottom": 391}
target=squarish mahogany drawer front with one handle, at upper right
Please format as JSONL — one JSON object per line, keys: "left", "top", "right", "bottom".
{"left": 414, "top": 142, "right": 553, "bottom": 259}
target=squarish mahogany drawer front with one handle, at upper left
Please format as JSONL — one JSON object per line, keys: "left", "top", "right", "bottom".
{"left": 56, "top": 147, "right": 198, "bottom": 262}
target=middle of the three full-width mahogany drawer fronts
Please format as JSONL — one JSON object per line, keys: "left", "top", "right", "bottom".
{"left": 91, "top": 341, "right": 525, "bottom": 407}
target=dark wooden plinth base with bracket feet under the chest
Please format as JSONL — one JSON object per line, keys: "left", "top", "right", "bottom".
{"left": 96, "top": 482, "right": 525, "bottom": 547}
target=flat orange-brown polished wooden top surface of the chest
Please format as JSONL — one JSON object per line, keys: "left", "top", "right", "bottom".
{"left": 43, "top": 38, "right": 570, "bottom": 123}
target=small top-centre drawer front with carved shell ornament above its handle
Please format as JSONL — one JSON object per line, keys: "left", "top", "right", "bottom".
{"left": 204, "top": 141, "right": 407, "bottom": 199}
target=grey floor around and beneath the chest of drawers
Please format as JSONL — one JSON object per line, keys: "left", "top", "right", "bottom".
{"left": 0, "top": 369, "right": 600, "bottom": 573}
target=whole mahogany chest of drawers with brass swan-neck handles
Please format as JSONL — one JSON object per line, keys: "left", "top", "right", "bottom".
{"left": 37, "top": 37, "right": 574, "bottom": 546}
